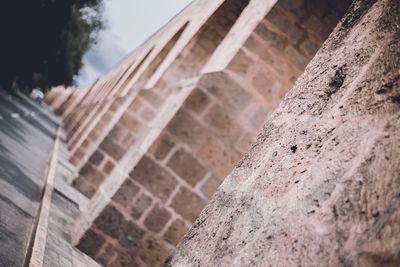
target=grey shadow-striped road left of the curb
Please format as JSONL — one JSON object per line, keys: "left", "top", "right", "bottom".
{"left": 0, "top": 90, "right": 58, "bottom": 266}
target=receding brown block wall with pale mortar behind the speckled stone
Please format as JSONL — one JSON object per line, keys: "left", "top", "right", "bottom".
{"left": 43, "top": 0, "right": 356, "bottom": 266}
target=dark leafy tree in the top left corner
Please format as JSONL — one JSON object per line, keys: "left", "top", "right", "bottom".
{"left": 0, "top": 0, "right": 103, "bottom": 92}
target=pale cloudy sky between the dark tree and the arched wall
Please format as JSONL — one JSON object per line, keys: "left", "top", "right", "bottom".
{"left": 75, "top": 0, "right": 191, "bottom": 87}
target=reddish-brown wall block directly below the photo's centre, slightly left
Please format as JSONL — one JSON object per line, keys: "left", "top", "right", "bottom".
{"left": 167, "top": 148, "right": 206, "bottom": 186}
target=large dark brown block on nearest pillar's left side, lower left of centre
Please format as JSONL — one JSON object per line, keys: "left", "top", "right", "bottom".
{"left": 129, "top": 155, "right": 176, "bottom": 201}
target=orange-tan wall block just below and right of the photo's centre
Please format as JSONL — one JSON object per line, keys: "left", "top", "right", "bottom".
{"left": 197, "top": 137, "right": 240, "bottom": 177}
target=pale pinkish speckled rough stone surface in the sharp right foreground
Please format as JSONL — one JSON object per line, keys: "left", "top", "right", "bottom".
{"left": 166, "top": 0, "right": 400, "bottom": 266}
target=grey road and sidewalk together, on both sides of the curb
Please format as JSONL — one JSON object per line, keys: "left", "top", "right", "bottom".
{"left": 0, "top": 89, "right": 99, "bottom": 267}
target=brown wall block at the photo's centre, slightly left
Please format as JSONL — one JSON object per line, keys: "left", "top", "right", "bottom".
{"left": 167, "top": 109, "right": 206, "bottom": 147}
